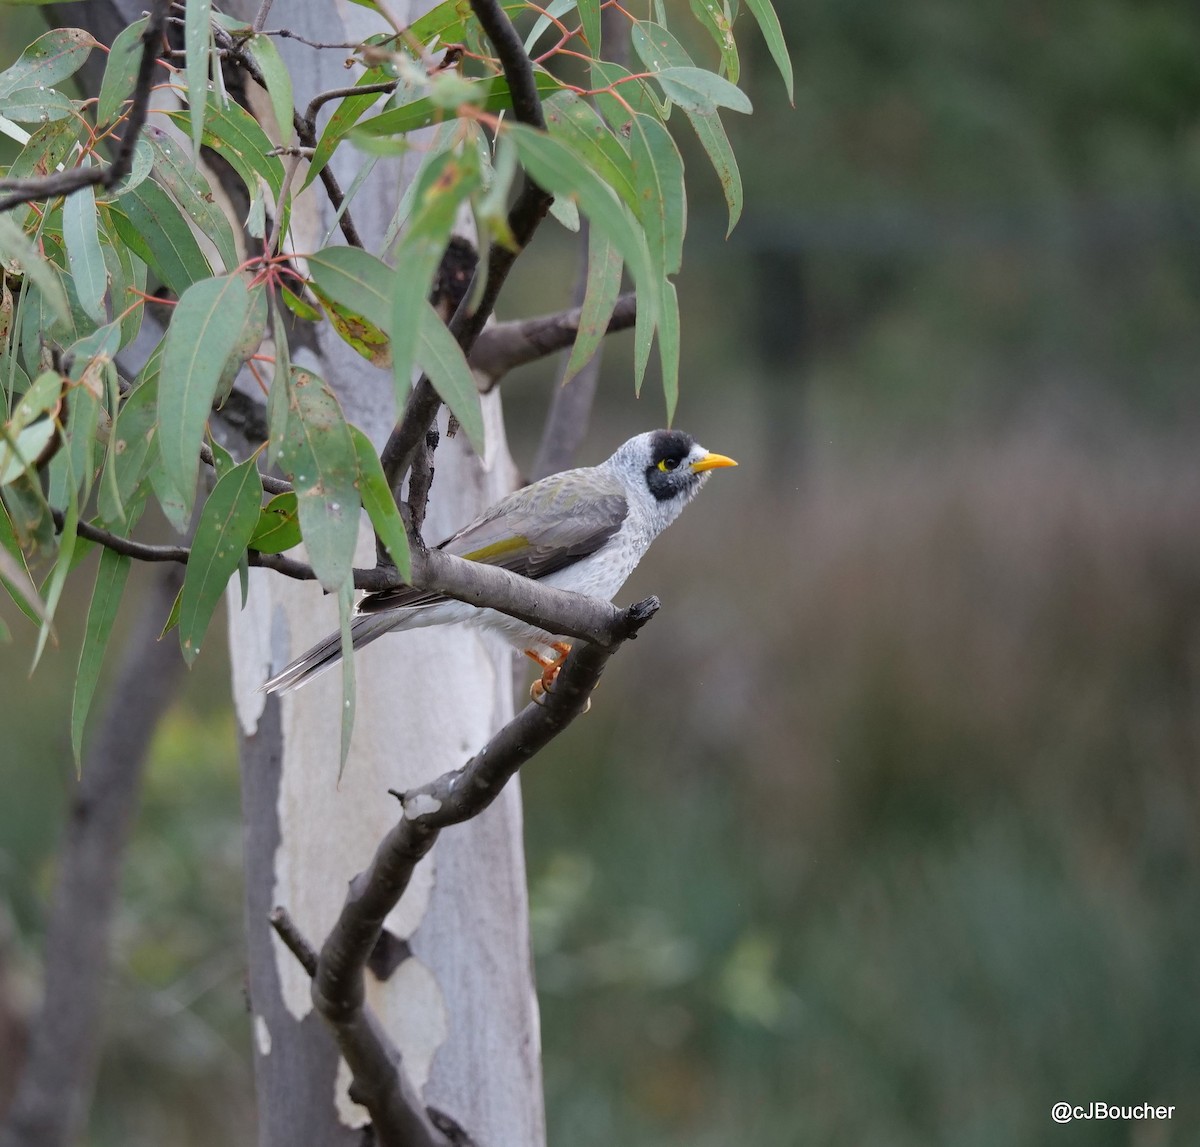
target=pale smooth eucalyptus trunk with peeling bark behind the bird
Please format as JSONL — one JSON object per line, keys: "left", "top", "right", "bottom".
{"left": 219, "top": 0, "right": 545, "bottom": 1147}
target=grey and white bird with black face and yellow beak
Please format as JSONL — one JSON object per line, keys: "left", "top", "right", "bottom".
{"left": 263, "top": 430, "right": 737, "bottom": 696}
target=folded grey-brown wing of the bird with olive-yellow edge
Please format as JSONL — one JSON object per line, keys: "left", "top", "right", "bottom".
{"left": 359, "top": 469, "right": 629, "bottom": 613}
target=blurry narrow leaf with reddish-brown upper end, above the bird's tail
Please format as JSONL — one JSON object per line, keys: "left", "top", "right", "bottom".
{"left": 388, "top": 150, "right": 481, "bottom": 409}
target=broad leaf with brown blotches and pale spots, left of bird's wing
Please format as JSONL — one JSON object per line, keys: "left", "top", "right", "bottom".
{"left": 280, "top": 367, "right": 359, "bottom": 593}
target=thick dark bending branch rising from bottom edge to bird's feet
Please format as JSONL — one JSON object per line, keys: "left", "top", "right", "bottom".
{"left": 271, "top": 597, "right": 659, "bottom": 1147}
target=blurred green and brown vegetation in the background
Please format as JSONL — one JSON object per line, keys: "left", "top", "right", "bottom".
{"left": 0, "top": 0, "right": 1200, "bottom": 1147}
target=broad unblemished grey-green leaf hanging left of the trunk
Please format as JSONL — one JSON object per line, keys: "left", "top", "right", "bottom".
{"left": 158, "top": 275, "right": 251, "bottom": 512}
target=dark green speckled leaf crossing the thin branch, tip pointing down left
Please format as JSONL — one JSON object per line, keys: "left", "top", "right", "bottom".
{"left": 179, "top": 456, "right": 263, "bottom": 665}
